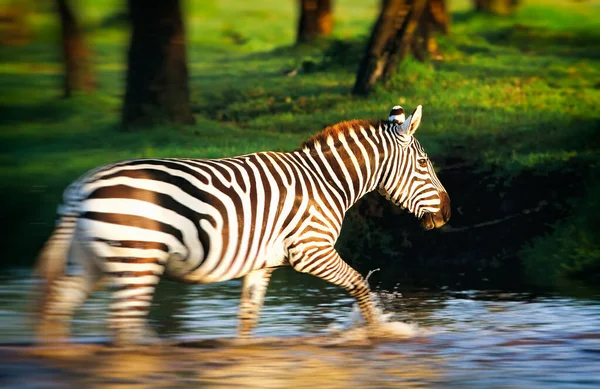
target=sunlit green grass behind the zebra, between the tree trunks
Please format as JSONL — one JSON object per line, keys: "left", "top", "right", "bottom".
{"left": 0, "top": 0, "right": 600, "bottom": 274}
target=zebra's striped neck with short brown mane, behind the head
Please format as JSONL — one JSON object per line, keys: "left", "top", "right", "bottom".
{"left": 296, "top": 121, "right": 396, "bottom": 211}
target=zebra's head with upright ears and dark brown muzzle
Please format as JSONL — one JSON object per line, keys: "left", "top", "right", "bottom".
{"left": 379, "top": 105, "right": 450, "bottom": 230}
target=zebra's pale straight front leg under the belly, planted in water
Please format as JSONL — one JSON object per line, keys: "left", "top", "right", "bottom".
{"left": 238, "top": 268, "right": 275, "bottom": 339}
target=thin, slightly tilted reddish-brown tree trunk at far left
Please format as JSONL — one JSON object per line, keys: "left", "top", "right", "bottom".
{"left": 56, "top": 0, "right": 95, "bottom": 97}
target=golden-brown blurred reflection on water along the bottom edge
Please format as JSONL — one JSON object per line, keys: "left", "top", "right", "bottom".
{"left": 7, "top": 343, "right": 443, "bottom": 389}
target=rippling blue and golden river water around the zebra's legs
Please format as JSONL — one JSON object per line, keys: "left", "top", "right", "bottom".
{"left": 0, "top": 270, "right": 600, "bottom": 388}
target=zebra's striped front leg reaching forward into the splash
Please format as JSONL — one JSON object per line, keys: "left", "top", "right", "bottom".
{"left": 290, "top": 246, "right": 380, "bottom": 328}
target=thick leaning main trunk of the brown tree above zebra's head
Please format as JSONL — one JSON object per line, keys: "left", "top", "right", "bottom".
{"left": 352, "top": 0, "right": 429, "bottom": 95}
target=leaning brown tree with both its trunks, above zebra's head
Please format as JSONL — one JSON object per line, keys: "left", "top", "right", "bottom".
{"left": 352, "top": 0, "right": 450, "bottom": 95}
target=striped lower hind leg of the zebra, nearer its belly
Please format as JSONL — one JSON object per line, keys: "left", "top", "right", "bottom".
{"left": 105, "top": 257, "right": 164, "bottom": 346}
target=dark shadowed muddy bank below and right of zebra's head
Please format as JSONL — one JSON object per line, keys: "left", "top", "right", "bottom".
{"left": 338, "top": 161, "right": 587, "bottom": 288}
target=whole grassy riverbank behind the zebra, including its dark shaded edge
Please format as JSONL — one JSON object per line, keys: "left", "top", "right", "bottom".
{"left": 0, "top": 0, "right": 600, "bottom": 283}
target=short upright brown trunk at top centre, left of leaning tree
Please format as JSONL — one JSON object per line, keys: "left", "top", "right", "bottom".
{"left": 296, "top": 0, "right": 333, "bottom": 43}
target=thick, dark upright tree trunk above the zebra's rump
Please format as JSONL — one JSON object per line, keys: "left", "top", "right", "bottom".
{"left": 122, "top": 0, "right": 195, "bottom": 128}
